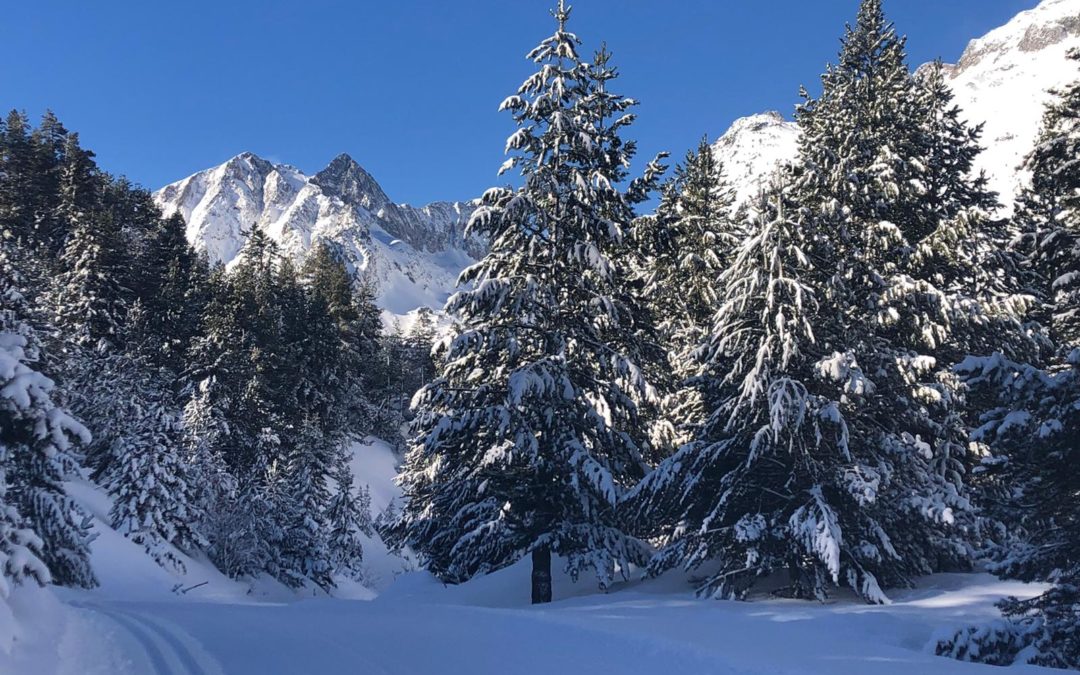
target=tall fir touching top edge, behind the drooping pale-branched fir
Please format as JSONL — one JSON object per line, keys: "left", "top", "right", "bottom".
{"left": 797, "top": 0, "right": 1027, "bottom": 599}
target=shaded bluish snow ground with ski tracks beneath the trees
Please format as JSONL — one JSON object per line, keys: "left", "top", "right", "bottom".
{"left": 0, "top": 436, "right": 1047, "bottom": 675}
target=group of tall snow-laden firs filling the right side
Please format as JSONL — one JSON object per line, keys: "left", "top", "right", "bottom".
{"left": 391, "top": 0, "right": 1080, "bottom": 665}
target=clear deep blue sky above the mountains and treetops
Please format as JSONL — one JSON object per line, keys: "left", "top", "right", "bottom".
{"left": 0, "top": 0, "right": 1036, "bottom": 203}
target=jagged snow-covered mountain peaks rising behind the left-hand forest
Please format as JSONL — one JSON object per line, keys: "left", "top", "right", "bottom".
{"left": 154, "top": 152, "right": 483, "bottom": 314}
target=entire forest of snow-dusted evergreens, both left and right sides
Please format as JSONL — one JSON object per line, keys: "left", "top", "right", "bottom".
{"left": 0, "top": 0, "right": 1080, "bottom": 667}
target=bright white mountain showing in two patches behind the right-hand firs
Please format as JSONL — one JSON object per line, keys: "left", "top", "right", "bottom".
{"left": 713, "top": 0, "right": 1080, "bottom": 206}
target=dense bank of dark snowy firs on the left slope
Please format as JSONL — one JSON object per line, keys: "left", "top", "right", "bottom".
{"left": 0, "top": 112, "right": 433, "bottom": 592}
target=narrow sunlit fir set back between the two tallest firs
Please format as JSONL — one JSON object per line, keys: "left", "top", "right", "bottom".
{"left": 635, "top": 138, "right": 745, "bottom": 451}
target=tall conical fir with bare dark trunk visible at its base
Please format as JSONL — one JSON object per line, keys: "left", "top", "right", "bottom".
{"left": 395, "top": 3, "right": 656, "bottom": 603}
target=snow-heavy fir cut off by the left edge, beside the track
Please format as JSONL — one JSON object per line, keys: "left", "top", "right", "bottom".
{"left": 0, "top": 241, "right": 97, "bottom": 595}
